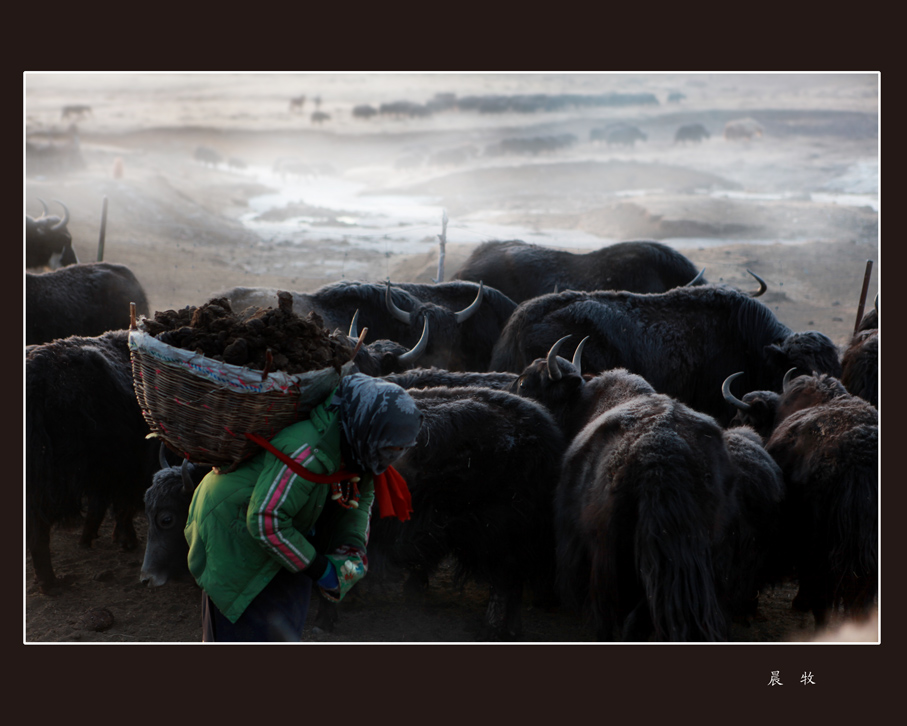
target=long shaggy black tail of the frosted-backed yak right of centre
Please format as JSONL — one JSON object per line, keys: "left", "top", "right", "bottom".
{"left": 634, "top": 472, "right": 728, "bottom": 641}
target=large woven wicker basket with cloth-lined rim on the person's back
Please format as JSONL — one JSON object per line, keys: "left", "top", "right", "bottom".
{"left": 129, "top": 322, "right": 351, "bottom": 473}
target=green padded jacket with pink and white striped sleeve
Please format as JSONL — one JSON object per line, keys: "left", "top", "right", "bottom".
{"left": 185, "top": 393, "right": 375, "bottom": 622}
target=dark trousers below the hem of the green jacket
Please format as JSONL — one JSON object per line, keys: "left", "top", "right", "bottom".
{"left": 202, "top": 568, "right": 312, "bottom": 643}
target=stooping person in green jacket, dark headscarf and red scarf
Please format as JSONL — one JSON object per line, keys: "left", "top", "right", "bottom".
{"left": 185, "top": 373, "right": 422, "bottom": 642}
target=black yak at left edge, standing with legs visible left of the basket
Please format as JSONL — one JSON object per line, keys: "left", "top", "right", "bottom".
{"left": 25, "top": 330, "right": 159, "bottom": 593}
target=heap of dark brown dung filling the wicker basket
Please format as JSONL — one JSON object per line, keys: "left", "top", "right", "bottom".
{"left": 144, "top": 292, "right": 353, "bottom": 374}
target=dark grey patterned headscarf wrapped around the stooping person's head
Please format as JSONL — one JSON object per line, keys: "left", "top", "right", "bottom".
{"left": 331, "top": 373, "right": 422, "bottom": 474}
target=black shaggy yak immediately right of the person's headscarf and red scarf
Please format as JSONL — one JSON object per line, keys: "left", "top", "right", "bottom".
{"left": 369, "top": 387, "right": 565, "bottom": 640}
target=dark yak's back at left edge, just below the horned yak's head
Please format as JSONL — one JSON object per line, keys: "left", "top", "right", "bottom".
{"left": 25, "top": 262, "right": 148, "bottom": 345}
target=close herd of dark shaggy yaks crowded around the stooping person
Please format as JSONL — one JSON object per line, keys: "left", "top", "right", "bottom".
{"left": 25, "top": 206, "right": 879, "bottom": 641}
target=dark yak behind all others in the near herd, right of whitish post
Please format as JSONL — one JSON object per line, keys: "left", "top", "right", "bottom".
{"left": 453, "top": 240, "right": 705, "bottom": 303}
